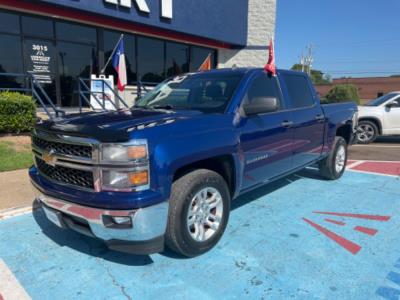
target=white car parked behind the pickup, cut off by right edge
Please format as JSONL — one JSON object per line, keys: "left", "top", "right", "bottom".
{"left": 357, "top": 92, "right": 400, "bottom": 144}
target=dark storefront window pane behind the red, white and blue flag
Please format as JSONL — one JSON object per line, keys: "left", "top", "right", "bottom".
{"left": 104, "top": 30, "right": 136, "bottom": 85}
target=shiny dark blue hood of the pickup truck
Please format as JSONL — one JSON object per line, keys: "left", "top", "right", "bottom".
{"left": 36, "top": 109, "right": 202, "bottom": 142}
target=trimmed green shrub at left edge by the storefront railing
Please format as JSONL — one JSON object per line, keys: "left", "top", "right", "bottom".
{"left": 0, "top": 92, "right": 36, "bottom": 133}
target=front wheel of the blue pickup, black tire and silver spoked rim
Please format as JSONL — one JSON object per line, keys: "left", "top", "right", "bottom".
{"left": 165, "top": 169, "right": 231, "bottom": 257}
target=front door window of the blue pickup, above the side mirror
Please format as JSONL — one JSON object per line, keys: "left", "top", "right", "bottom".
{"left": 244, "top": 75, "right": 282, "bottom": 108}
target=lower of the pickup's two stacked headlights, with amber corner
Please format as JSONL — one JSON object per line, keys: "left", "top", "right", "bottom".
{"left": 102, "top": 169, "right": 149, "bottom": 191}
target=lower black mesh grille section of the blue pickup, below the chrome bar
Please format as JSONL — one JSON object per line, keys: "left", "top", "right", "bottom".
{"left": 36, "top": 157, "right": 94, "bottom": 189}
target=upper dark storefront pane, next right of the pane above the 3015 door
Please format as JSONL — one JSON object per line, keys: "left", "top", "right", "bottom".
{"left": 56, "top": 22, "right": 97, "bottom": 44}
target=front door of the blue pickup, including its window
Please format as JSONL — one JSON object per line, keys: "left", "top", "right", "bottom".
{"left": 238, "top": 72, "right": 293, "bottom": 189}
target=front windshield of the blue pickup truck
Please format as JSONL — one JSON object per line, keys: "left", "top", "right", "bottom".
{"left": 135, "top": 73, "right": 243, "bottom": 113}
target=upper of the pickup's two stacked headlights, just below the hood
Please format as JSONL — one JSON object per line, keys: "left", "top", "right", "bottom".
{"left": 101, "top": 140, "right": 148, "bottom": 162}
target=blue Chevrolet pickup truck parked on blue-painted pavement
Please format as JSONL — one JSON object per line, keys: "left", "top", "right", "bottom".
{"left": 29, "top": 68, "right": 357, "bottom": 257}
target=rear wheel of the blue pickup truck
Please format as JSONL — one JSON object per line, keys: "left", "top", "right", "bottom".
{"left": 319, "top": 136, "right": 347, "bottom": 180}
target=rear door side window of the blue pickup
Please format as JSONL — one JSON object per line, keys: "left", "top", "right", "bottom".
{"left": 283, "top": 74, "right": 314, "bottom": 108}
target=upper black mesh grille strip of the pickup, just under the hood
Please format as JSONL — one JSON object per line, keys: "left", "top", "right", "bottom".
{"left": 32, "top": 136, "right": 92, "bottom": 158}
